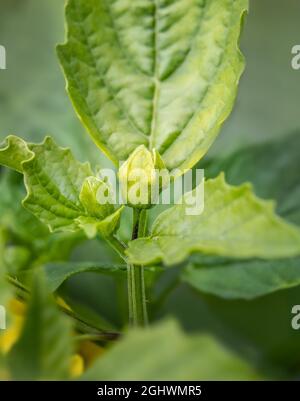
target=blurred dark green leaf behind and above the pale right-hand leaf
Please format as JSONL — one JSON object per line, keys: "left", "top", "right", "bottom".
{"left": 201, "top": 132, "right": 300, "bottom": 224}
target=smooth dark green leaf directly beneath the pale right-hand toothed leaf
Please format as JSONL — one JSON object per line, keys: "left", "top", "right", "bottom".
{"left": 182, "top": 258, "right": 300, "bottom": 299}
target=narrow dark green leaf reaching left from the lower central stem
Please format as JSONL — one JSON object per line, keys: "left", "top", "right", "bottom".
{"left": 45, "top": 262, "right": 127, "bottom": 292}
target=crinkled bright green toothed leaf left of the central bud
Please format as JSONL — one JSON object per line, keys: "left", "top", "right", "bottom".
{"left": 0, "top": 136, "right": 123, "bottom": 237}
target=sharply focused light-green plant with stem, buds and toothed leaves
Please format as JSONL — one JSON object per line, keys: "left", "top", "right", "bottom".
{"left": 0, "top": 0, "right": 300, "bottom": 332}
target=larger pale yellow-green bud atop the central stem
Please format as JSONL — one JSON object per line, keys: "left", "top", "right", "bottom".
{"left": 119, "top": 145, "right": 169, "bottom": 209}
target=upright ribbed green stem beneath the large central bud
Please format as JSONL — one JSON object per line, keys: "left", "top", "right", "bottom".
{"left": 127, "top": 209, "right": 148, "bottom": 327}
